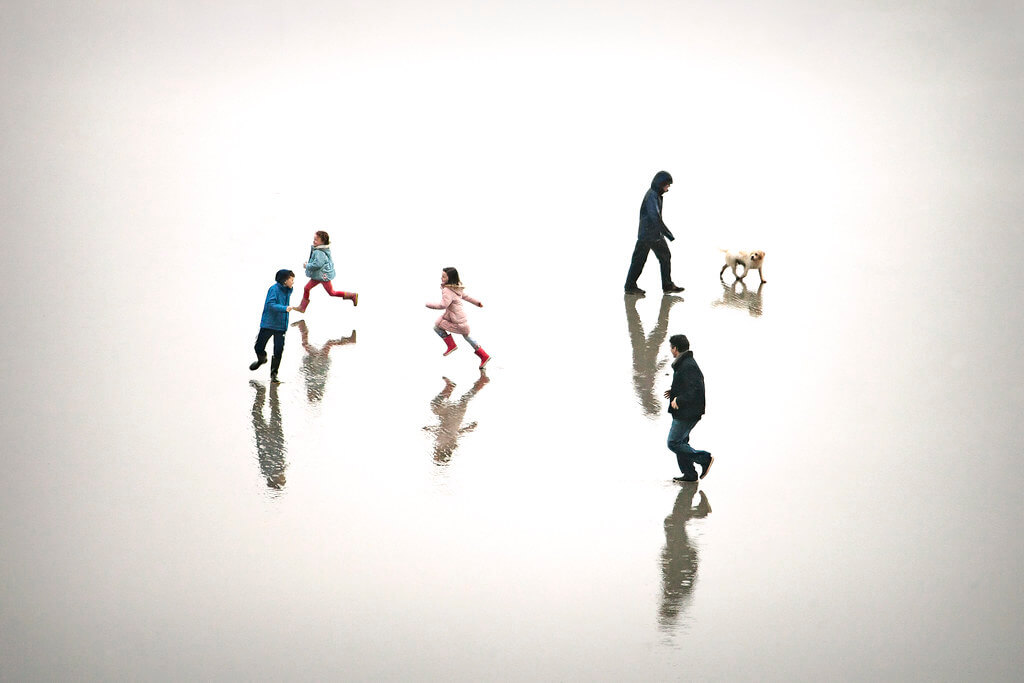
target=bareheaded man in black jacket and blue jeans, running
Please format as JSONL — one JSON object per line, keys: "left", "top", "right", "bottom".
{"left": 665, "top": 335, "right": 715, "bottom": 482}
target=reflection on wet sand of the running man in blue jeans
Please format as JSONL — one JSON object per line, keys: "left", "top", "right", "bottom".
{"left": 657, "top": 486, "right": 711, "bottom": 630}
